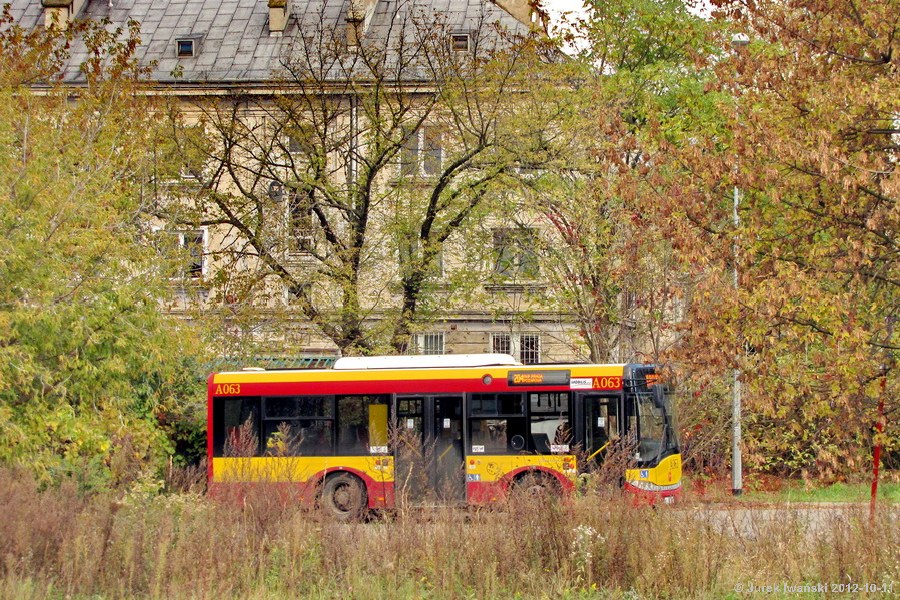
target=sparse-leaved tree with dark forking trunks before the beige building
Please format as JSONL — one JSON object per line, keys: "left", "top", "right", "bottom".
{"left": 163, "top": 3, "right": 558, "bottom": 353}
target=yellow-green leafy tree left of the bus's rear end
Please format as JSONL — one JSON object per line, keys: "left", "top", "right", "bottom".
{"left": 0, "top": 9, "right": 204, "bottom": 487}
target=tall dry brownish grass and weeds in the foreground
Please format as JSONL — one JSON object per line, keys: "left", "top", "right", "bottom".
{"left": 0, "top": 470, "right": 900, "bottom": 599}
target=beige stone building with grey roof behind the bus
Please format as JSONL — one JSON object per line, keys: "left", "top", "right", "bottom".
{"left": 12, "top": 0, "right": 596, "bottom": 363}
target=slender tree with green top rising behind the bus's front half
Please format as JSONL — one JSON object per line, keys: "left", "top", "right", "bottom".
{"left": 529, "top": 0, "right": 710, "bottom": 362}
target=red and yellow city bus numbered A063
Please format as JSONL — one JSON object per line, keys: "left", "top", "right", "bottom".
{"left": 208, "top": 354, "right": 681, "bottom": 517}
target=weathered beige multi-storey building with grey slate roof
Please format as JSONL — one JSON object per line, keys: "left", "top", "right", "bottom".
{"left": 12, "top": 0, "right": 596, "bottom": 363}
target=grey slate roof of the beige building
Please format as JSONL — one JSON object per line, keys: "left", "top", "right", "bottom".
{"left": 11, "top": 0, "right": 527, "bottom": 85}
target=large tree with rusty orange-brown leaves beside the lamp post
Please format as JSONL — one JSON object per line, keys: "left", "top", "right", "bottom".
{"left": 668, "top": 0, "right": 900, "bottom": 478}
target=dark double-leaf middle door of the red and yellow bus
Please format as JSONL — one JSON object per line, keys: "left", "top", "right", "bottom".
{"left": 393, "top": 396, "right": 466, "bottom": 503}
